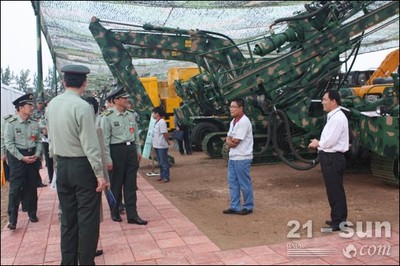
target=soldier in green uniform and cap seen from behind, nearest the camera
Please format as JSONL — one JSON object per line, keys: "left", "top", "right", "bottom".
{"left": 45, "top": 65, "right": 103, "bottom": 265}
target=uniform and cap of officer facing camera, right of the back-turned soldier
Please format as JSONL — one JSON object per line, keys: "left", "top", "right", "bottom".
{"left": 101, "top": 83, "right": 147, "bottom": 224}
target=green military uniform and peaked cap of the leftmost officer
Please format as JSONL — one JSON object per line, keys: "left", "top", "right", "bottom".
{"left": 4, "top": 93, "right": 42, "bottom": 229}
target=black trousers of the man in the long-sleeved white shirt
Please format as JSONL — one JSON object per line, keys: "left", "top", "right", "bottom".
{"left": 319, "top": 151, "right": 347, "bottom": 227}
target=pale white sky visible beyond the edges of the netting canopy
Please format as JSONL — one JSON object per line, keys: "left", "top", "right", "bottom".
{"left": 1, "top": 1, "right": 393, "bottom": 83}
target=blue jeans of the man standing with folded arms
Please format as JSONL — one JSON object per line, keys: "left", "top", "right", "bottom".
{"left": 228, "top": 160, "right": 254, "bottom": 211}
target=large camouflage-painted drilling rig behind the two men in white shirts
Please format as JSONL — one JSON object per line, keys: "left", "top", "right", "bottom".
{"left": 190, "top": 1, "right": 399, "bottom": 181}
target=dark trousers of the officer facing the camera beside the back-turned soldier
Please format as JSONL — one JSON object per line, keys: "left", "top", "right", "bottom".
{"left": 110, "top": 144, "right": 139, "bottom": 220}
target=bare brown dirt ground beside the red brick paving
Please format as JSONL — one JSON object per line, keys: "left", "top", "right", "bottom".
{"left": 1, "top": 145, "right": 399, "bottom": 250}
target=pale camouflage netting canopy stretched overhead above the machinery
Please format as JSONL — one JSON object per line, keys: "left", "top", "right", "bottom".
{"left": 36, "top": 1, "right": 399, "bottom": 90}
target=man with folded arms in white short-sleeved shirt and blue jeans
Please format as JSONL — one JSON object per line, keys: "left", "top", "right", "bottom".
{"left": 222, "top": 98, "right": 254, "bottom": 215}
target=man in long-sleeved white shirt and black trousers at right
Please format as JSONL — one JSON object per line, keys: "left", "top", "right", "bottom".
{"left": 309, "top": 90, "right": 349, "bottom": 232}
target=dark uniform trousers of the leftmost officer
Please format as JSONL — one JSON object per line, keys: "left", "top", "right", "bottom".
{"left": 7, "top": 149, "right": 40, "bottom": 224}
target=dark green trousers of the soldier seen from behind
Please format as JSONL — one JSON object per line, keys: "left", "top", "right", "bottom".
{"left": 56, "top": 156, "right": 101, "bottom": 265}
